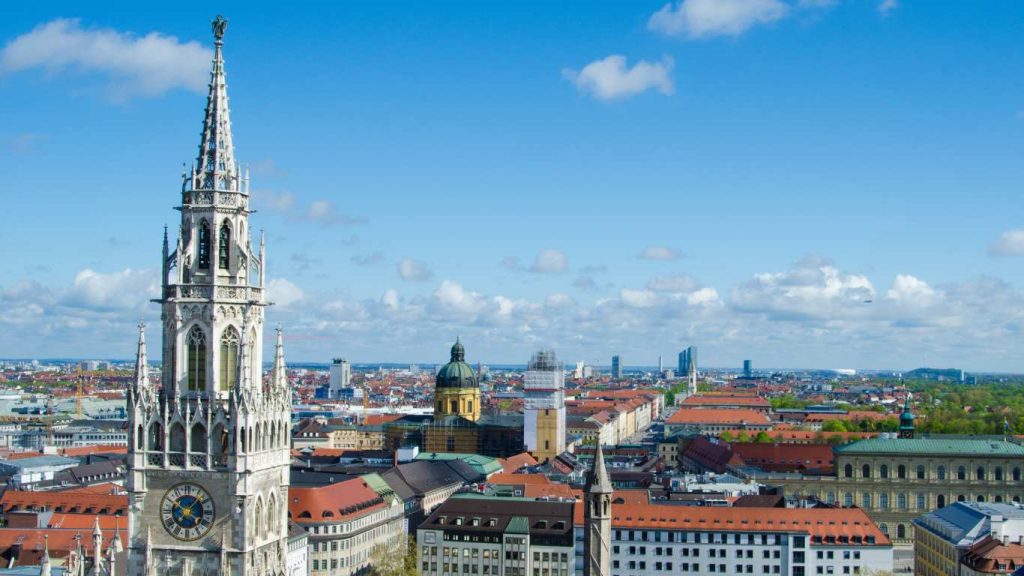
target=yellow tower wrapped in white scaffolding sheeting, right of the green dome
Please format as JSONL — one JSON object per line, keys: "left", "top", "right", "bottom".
{"left": 522, "top": 351, "right": 565, "bottom": 461}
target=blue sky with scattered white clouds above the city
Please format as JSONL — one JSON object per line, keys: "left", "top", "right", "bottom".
{"left": 0, "top": 0, "right": 1024, "bottom": 371}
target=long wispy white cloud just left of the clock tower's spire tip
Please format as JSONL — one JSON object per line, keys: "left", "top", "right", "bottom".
{"left": 0, "top": 18, "right": 213, "bottom": 99}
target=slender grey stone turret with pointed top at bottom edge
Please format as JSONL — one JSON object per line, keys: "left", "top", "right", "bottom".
{"left": 583, "top": 443, "right": 613, "bottom": 576}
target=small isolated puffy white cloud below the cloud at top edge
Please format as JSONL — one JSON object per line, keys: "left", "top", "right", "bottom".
{"left": 562, "top": 54, "right": 675, "bottom": 100}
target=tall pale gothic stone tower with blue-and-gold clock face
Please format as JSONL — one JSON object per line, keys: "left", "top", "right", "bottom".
{"left": 127, "top": 16, "right": 291, "bottom": 576}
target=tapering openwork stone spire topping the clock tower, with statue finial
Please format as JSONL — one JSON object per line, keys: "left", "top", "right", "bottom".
{"left": 192, "top": 15, "right": 242, "bottom": 192}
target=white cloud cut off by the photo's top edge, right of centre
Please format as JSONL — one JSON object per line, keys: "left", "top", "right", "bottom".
{"left": 647, "top": 0, "right": 788, "bottom": 38}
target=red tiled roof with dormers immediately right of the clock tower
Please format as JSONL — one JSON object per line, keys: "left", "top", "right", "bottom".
{"left": 288, "top": 478, "right": 384, "bottom": 524}
